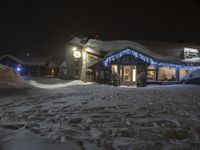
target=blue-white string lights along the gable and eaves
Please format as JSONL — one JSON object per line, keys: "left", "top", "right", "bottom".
{"left": 103, "top": 48, "right": 200, "bottom": 70}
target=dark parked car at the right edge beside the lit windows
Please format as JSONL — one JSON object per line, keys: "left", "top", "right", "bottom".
{"left": 180, "top": 69, "right": 200, "bottom": 84}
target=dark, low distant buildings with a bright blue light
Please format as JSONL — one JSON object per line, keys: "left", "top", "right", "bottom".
{"left": 0, "top": 55, "right": 60, "bottom": 77}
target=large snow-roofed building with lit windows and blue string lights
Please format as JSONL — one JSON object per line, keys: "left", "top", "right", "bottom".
{"left": 70, "top": 38, "right": 200, "bottom": 85}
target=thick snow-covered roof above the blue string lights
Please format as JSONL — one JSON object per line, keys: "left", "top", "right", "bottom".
{"left": 70, "top": 38, "right": 200, "bottom": 64}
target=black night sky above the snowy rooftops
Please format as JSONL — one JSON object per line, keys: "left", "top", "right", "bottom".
{"left": 0, "top": 0, "right": 200, "bottom": 55}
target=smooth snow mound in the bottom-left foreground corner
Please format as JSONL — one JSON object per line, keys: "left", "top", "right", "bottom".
{"left": 0, "top": 129, "right": 80, "bottom": 150}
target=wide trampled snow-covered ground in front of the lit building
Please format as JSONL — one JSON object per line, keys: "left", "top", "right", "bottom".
{"left": 0, "top": 81, "right": 200, "bottom": 150}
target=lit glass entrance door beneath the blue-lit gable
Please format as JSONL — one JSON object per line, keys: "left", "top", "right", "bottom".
{"left": 122, "top": 65, "right": 136, "bottom": 85}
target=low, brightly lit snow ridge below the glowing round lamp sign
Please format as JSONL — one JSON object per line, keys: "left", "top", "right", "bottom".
{"left": 29, "top": 80, "right": 93, "bottom": 89}
